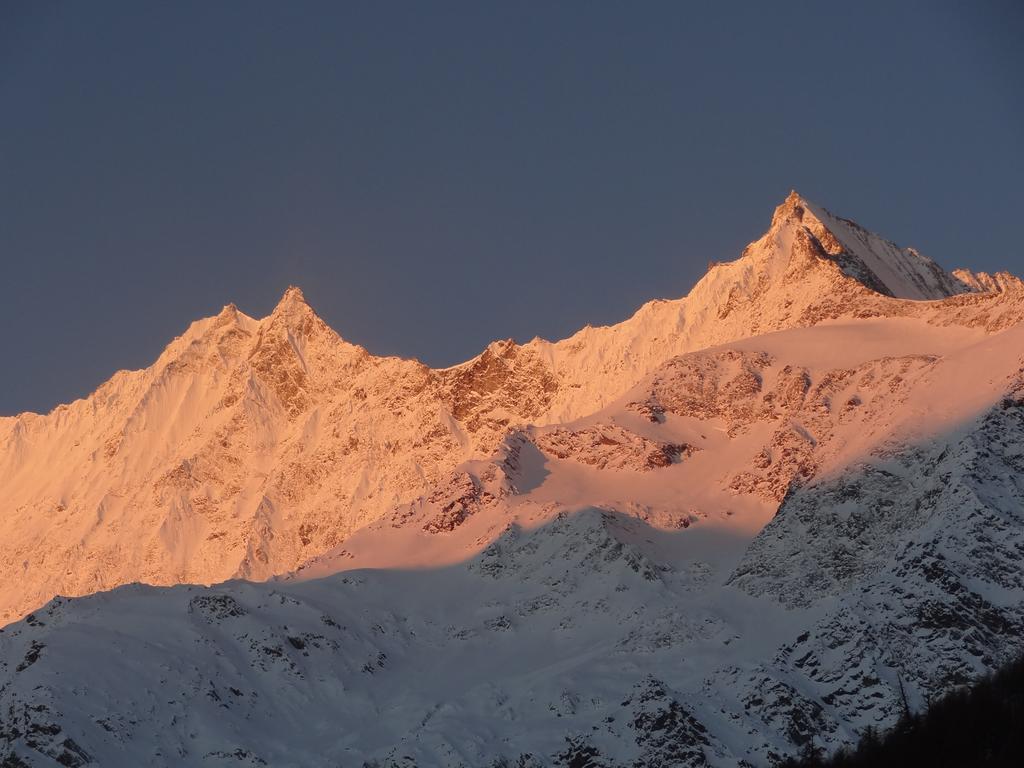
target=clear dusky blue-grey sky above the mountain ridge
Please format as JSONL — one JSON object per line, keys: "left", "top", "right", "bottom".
{"left": 0, "top": 0, "right": 1024, "bottom": 414}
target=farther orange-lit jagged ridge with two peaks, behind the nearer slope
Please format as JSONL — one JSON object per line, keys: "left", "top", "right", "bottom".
{"left": 0, "top": 194, "right": 1024, "bottom": 621}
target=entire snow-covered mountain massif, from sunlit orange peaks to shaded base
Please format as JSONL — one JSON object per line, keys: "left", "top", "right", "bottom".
{"left": 0, "top": 194, "right": 1024, "bottom": 766}
